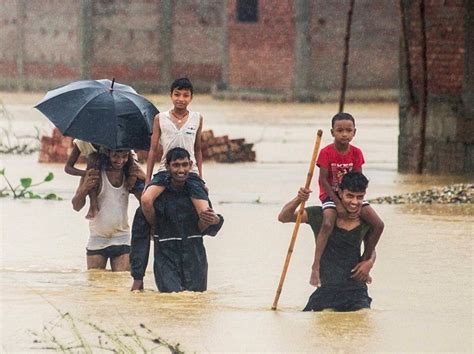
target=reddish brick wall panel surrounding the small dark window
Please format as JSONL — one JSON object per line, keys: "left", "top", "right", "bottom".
{"left": 228, "top": 0, "right": 295, "bottom": 91}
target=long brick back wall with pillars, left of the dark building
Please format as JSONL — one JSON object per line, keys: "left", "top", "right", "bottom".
{"left": 0, "top": 0, "right": 399, "bottom": 98}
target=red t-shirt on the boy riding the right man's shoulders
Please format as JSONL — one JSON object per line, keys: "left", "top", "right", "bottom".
{"left": 316, "top": 144, "right": 365, "bottom": 201}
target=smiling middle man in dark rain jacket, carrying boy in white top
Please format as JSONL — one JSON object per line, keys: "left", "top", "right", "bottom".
{"left": 130, "top": 148, "right": 224, "bottom": 292}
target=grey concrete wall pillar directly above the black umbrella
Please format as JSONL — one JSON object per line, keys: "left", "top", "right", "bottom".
{"left": 79, "top": 0, "right": 94, "bottom": 79}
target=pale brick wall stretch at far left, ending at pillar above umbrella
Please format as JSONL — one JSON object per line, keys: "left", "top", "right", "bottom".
{"left": 0, "top": 0, "right": 80, "bottom": 89}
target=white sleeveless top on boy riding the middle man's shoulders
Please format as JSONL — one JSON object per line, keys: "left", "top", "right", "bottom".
{"left": 158, "top": 110, "right": 201, "bottom": 173}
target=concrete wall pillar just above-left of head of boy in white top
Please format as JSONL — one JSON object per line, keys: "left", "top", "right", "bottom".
{"left": 158, "top": 0, "right": 173, "bottom": 89}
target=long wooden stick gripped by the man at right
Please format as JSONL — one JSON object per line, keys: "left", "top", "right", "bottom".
{"left": 272, "top": 129, "right": 323, "bottom": 310}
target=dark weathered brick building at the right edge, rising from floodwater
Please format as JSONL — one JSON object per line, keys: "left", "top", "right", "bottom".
{"left": 398, "top": 0, "right": 474, "bottom": 174}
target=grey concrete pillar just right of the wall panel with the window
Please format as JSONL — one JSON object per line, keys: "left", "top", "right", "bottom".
{"left": 293, "top": 0, "right": 311, "bottom": 101}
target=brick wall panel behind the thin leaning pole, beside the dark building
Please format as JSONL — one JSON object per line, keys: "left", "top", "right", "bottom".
{"left": 310, "top": 0, "right": 400, "bottom": 91}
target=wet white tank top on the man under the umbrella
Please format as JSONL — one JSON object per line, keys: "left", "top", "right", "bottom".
{"left": 87, "top": 170, "right": 130, "bottom": 250}
